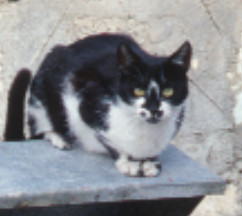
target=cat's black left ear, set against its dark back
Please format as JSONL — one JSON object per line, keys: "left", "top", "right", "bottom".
{"left": 117, "top": 43, "right": 138, "bottom": 69}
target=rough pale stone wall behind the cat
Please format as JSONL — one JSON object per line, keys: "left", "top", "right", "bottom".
{"left": 0, "top": 0, "right": 242, "bottom": 216}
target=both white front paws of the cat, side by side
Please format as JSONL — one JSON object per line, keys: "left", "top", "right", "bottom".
{"left": 115, "top": 156, "right": 161, "bottom": 177}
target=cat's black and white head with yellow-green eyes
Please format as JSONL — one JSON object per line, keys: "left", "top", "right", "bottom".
{"left": 117, "top": 41, "right": 192, "bottom": 123}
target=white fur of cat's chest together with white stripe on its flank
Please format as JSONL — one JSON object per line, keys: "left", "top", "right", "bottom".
{"left": 63, "top": 80, "right": 181, "bottom": 159}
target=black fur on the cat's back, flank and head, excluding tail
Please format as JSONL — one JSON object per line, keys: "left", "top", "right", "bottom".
{"left": 30, "top": 34, "right": 190, "bottom": 143}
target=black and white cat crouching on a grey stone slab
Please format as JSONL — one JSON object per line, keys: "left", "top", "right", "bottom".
{"left": 6, "top": 33, "right": 192, "bottom": 177}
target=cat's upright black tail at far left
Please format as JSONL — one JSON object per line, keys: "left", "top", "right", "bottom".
{"left": 4, "top": 69, "right": 31, "bottom": 141}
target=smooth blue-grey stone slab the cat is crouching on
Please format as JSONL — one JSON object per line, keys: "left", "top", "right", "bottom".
{"left": 0, "top": 141, "right": 225, "bottom": 208}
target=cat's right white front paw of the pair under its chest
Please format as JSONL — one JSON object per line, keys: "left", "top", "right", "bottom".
{"left": 141, "top": 161, "right": 161, "bottom": 177}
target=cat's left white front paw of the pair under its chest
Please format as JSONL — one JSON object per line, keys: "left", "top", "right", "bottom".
{"left": 115, "top": 156, "right": 140, "bottom": 176}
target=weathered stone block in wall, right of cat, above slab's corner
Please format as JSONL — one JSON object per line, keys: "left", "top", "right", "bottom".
{"left": 175, "top": 130, "right": 234, "bottom": 175}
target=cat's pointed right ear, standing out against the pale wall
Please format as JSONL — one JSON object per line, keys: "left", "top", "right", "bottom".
{"left": 169, "top": 41, "right": 192, "bottom": 72}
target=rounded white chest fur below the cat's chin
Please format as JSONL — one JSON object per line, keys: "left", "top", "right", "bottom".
{"left": 102, "top": 102, "right": 180, "bottom": 159}
